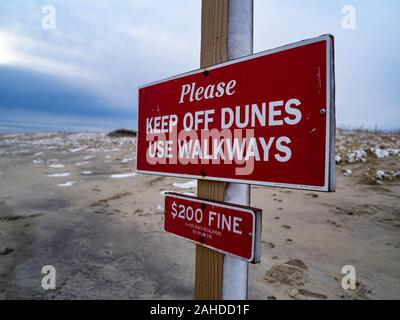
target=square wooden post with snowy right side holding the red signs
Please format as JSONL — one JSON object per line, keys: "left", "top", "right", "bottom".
{"left": 195, "top": 0, "right": 253, "bottom": 300}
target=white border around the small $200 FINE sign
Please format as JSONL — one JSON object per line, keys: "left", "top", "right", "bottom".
{"left": 163, "top": 192, "right": 262, "bottom": 263}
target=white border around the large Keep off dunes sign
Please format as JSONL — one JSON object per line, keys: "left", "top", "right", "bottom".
{"left": 136, "top": 35, "right": 336, "bottom": 192}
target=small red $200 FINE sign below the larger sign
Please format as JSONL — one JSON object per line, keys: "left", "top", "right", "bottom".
{"left": 164, "top": 193, "right": 261, "bottom": 263}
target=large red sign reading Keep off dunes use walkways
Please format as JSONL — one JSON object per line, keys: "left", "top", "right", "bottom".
{"left": 137, "top": 36, "right": 335, "bottom": 191}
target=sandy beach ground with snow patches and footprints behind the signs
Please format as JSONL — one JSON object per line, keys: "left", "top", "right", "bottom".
{"left": 0, "top": 131, "right": 400, "bottom": 299}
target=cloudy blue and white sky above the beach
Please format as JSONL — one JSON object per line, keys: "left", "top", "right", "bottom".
{"left": 0, "top": 0, "right": 400, "bottom": 131}
